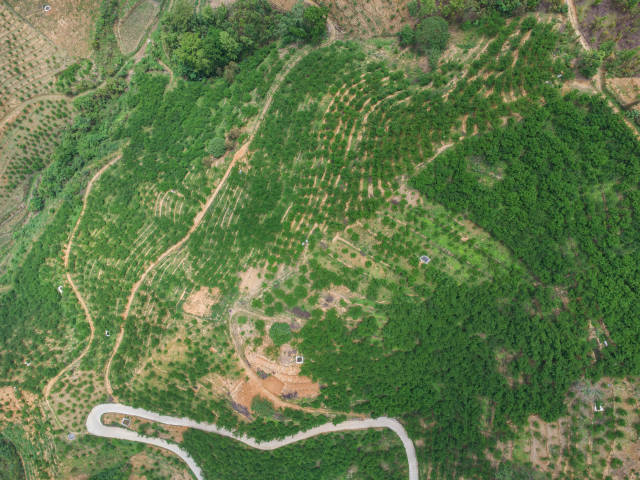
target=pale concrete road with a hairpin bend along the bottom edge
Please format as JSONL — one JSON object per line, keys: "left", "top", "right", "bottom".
{"left": 87, "top": 403, "right": 418, "bottom": 480}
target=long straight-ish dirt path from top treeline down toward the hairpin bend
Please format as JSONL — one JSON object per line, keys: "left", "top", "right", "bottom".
{"left": 104, "top": 49, "right": 308, "bottom": 397}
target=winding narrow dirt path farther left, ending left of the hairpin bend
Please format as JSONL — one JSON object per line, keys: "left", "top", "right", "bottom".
{"left": 43, "top": 155, "right": 120, "bottom": 420}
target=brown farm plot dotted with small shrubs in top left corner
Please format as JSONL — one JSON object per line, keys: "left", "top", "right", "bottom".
{"left": 0, "top": 3, "right": 71, "bottom": 121}
